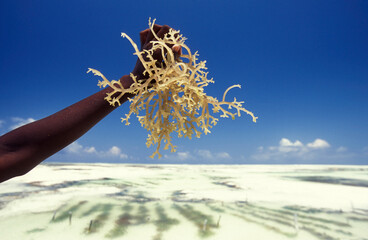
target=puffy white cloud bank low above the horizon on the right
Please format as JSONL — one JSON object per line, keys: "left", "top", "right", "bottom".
{"left": 251, "top": 138, "right": 332, "bottom": 161}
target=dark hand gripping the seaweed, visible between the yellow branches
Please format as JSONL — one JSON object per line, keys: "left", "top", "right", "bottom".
{"left": 132, "top": 24, "right": 181, "bottom": 80}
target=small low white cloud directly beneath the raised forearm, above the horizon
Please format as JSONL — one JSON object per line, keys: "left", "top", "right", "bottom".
{"left": 65, "top": 142, "right": 128, "bottom": 159}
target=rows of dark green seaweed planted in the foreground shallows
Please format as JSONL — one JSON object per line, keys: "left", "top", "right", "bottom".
{"left": 20, "top": 197, "right": 368, "bottom": 240}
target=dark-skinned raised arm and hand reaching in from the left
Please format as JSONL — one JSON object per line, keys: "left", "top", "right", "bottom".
{"left": 0, "top": 25, "right": 177, "bottom": 182}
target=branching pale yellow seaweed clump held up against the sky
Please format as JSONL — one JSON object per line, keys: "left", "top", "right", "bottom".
{"left": 88, "top": 20, "right": 257, "bottom": 158}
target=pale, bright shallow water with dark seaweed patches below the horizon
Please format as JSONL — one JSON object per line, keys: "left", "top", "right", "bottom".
{"left": 0, "top": 164, "right": 368, "bottom": 240}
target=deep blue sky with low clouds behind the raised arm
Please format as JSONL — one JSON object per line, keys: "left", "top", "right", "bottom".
{"left": 0, "top": 0, "right": 368, "bottom": 164}
